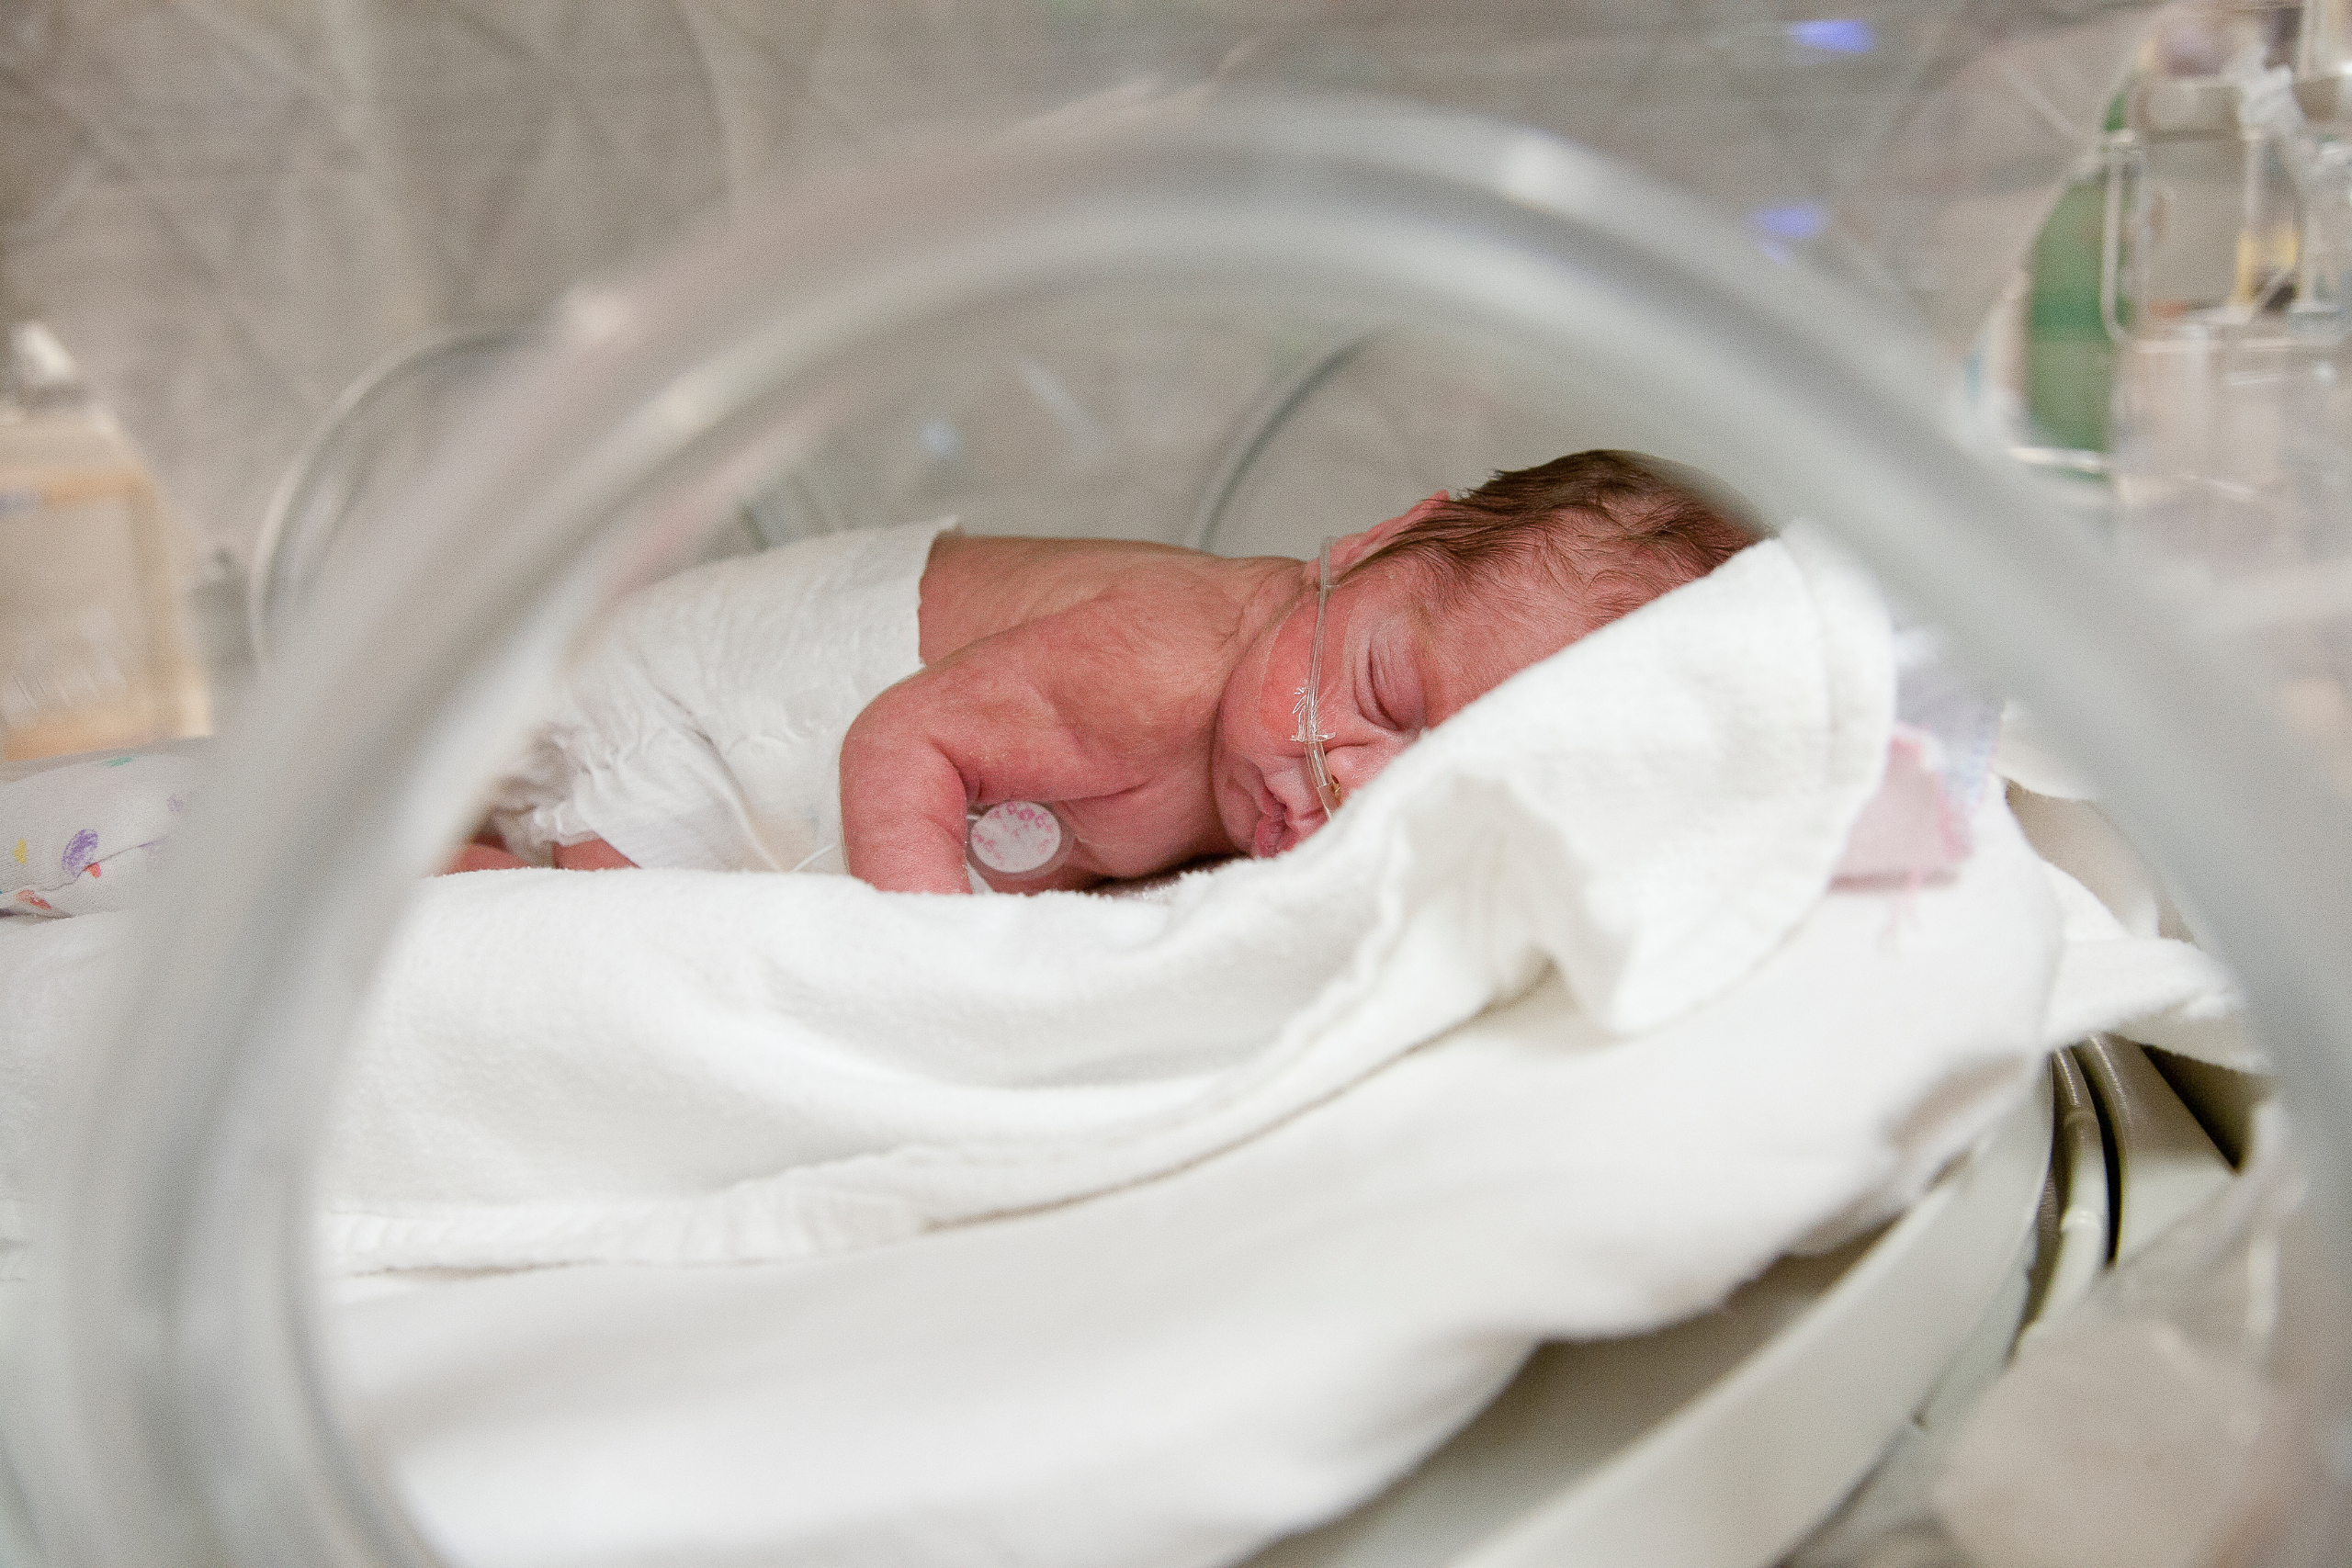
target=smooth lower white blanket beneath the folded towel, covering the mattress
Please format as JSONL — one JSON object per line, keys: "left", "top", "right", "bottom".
{"left": 334, "top": 807, "right": 2218, "bottom": 1568}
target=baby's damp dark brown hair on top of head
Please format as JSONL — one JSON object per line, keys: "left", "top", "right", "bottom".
{"left": 1350, "top": 451, "right": 1757, "bottom": 635}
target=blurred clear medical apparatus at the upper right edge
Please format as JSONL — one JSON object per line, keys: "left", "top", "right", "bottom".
{"left": 2103, "top": 0, "right": 2352, "bottom": 790}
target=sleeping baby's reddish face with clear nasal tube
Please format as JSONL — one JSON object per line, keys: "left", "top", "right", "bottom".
{"left": 1209, "top": 526, "right": 1569, "bottom": 856}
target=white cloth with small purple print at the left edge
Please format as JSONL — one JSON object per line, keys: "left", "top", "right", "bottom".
{"left": 0, "top": 752, "right": 198, "bottom": 917}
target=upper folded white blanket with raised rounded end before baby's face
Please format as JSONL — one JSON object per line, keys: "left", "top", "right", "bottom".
{"left": 312, "top": 541, "right": 1900, "bottom": 1269}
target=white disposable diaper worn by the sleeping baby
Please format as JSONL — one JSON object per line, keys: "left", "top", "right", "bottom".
{"left": 492, "top": 517, "right": 955, "bottom": 872}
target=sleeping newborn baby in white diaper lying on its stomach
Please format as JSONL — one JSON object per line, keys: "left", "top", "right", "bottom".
{"left": 461, "top": 451, "right": 1750, "bottom": 894}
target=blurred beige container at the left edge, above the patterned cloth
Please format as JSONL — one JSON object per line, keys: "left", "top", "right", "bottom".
{"left": 0, "top": 322, "right": 209, "bottom": 760}
